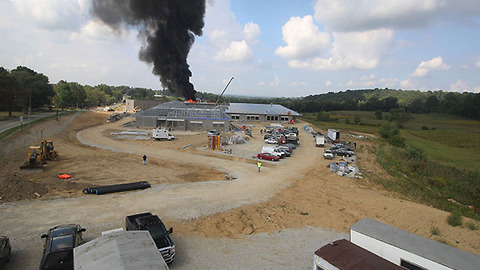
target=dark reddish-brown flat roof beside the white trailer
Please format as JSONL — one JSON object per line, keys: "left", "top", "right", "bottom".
{"left": 315, "top": 239, "right": 404, "bottom": 270}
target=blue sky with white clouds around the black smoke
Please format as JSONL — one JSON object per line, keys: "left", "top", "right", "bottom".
{"left": 0, "top": 0, "right": 480, "bottom": 97}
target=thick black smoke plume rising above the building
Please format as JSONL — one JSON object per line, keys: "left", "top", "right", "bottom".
{"left": 92, "top": 0, "right": 205, "bottom": 100}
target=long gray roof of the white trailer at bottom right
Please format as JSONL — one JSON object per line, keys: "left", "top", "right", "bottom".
{"left": 350, "top": 218, "right": 480, "bottom": 270}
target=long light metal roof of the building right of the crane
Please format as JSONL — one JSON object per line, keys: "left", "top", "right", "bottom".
{"left": 225, "top": 103, "right": 300, "bottom": 116}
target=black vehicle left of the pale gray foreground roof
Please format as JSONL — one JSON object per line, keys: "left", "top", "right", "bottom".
{"left": 39, "top": 224, "right": 86, "bottom": 270}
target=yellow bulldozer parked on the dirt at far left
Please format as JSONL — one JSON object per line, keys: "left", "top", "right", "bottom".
{"left": 20, "top": 140, "right": 58, "bottom": 170}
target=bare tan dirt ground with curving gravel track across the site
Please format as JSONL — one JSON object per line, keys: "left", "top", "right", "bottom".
{"left": 0, "top": 112, "right": 480, "bottom": 268}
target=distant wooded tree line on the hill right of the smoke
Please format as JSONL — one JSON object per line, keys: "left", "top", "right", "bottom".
{"left": 197, "top": 88, "right": 480, "bottom": 120}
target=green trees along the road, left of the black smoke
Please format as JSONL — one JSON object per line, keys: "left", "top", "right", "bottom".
{"left": 0, "top": 66, "right": 168, "bottom": 116}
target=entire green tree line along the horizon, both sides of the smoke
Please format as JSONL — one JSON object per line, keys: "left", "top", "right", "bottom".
{"left": 0, "top": 66, "right": 480, "bottom": 119}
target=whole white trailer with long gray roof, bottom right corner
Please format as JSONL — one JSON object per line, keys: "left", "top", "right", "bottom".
{"left": 350, "top": 218, "right": 480, "bottom": 270}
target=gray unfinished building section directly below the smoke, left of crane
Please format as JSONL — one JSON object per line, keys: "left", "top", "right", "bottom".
{"left": 135, "top": 101, "right": 230, "bottom": 132}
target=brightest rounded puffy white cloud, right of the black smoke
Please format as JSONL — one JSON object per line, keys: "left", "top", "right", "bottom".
{"left": 275, "top": 16, "right": 331, "bottom": 59}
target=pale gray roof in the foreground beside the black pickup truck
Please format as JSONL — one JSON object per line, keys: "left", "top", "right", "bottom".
{"left": 73, "top": 231, "right": 168, "bottom": 270}
